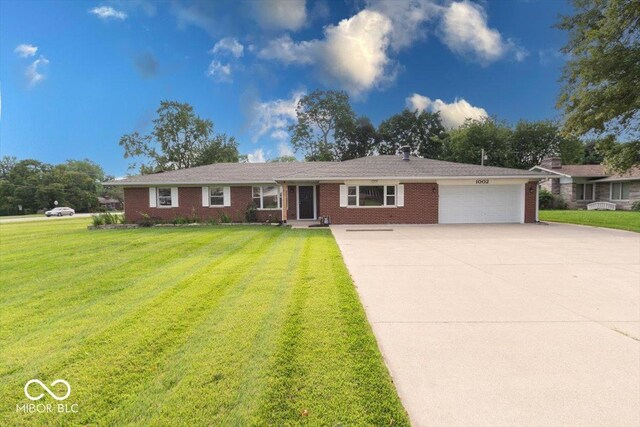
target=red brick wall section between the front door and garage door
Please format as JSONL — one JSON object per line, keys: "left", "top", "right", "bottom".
{"left": 318, "top": 183, "right": 438, "bottom": 224}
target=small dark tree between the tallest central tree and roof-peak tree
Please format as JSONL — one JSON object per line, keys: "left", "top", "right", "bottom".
{"left": 336, "top": 116, "right": 380, "bottom": 160}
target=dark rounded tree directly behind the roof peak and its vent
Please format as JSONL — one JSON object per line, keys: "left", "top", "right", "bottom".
{"left": 378, "top": 109, "right": 446, "bottom": 159}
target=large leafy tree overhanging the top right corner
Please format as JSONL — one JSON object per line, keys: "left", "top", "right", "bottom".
{"left": 557, "top": 0, "right": 640, "bottom": 171}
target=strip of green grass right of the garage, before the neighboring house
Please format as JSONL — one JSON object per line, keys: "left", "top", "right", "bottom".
{"left": 539, "top": 210, "right": 640, "bottom": 233}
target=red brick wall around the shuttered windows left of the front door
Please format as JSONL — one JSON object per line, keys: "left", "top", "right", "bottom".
{"left": 124, "top": 187, "right": 282, "bottom": 222}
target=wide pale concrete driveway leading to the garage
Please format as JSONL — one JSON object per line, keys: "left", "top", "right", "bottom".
{"left": 331, "top": 224, "right": 640, "bottom": 426}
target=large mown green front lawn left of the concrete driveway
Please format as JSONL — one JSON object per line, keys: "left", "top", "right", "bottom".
{"left": 0, "top": 219, "right": 408, "bottom": 426}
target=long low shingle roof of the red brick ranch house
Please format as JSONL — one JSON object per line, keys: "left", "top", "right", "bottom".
{"left": 109, "top": 156, "right": 548, "bottom": 185}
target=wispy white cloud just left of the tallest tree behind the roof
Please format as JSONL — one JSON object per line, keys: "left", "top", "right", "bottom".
{"left": 250, "top": 91, "right": 304, "bottom": 142}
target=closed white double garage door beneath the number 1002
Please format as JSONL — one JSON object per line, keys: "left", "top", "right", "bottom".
{"left": 438, "top": 184, "right": 524, "bottom": 224}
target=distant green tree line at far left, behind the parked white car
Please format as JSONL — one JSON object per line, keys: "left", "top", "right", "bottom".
{"left": 0, "top": 156, "right": 123, "bottom": 215}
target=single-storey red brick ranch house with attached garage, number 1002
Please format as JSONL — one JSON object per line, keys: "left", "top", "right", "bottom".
{"left": 105, "top": 154, "right": 551, "bottom": 224}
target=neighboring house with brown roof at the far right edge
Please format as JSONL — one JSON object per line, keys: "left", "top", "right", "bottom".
{"left": 531, "top": 157, "right": 640, "bottom": 209}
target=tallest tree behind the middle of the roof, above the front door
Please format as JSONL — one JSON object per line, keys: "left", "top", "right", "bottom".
{"left": 288, "top": 90, "right": 355, "bottom": 161}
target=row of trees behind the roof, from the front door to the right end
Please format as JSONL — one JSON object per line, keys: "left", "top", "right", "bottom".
{"left": 289, "top": 90, "right": 602, "bottom": 169}
